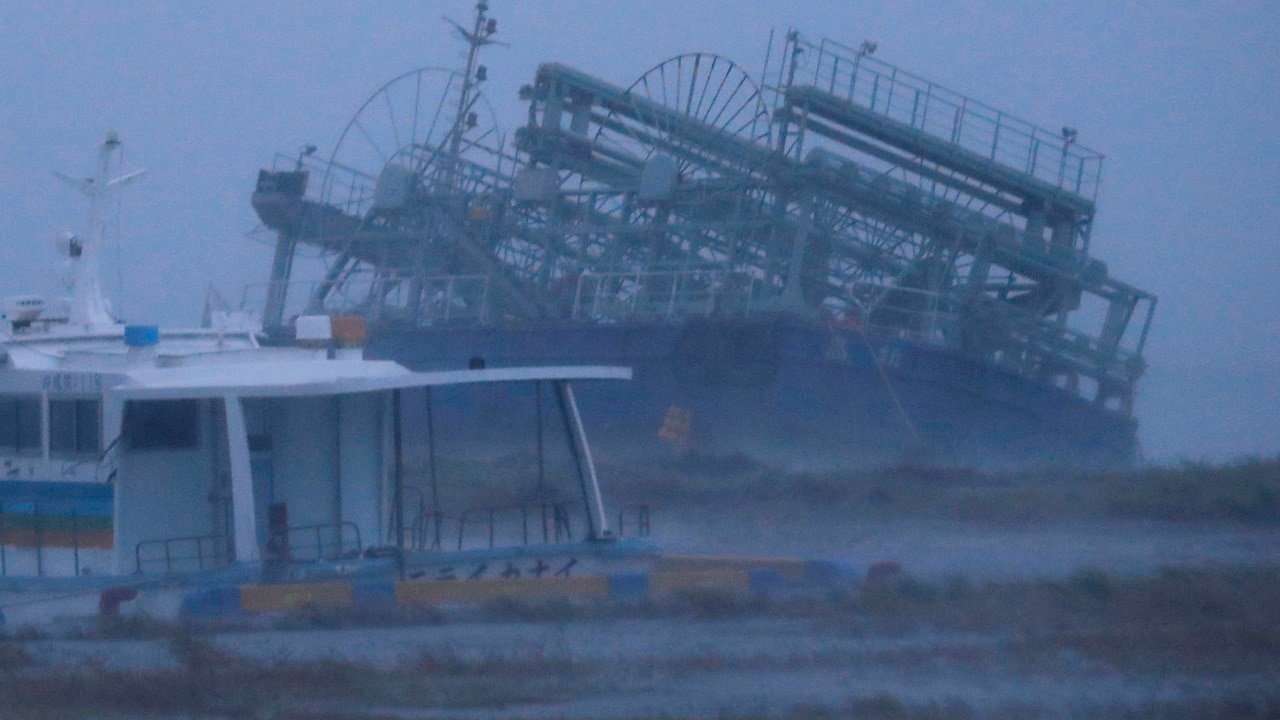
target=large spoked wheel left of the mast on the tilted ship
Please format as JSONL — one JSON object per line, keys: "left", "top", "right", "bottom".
{"left": 296, "top": 68, "right": 502, "bottom": 319}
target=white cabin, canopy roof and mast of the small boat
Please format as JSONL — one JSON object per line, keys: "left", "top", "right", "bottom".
{"left": 0, "top": 133, "right": 631, "bottom": 584}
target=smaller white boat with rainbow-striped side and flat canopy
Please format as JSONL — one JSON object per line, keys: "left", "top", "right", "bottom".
{"left": 0, "top": 132, "right": 657, "bottom": 607}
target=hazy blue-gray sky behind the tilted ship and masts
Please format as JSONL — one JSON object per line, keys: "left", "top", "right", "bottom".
{"left": 0, "top": 0, "right": 1280, "bottom": 461}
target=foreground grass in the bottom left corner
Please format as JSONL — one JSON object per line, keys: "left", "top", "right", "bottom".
{"left": 0, "top": 634, "right": 593, "bottom": 719}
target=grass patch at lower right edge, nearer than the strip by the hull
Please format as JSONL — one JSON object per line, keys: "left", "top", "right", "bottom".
{"left": 840, "top": 566, "right": 1280, "bottom": 674}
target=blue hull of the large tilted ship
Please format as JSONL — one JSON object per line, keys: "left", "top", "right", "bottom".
{"left": 369, "top": 318, "right": 1137, "bottom": 468}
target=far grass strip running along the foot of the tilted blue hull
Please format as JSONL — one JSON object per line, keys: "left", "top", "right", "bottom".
{"left": 602, "top": 457, "right": 1280, "bottom": 524}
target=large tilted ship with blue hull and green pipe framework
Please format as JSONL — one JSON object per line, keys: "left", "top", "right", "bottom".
{"left": 242, "top": 1, "right": 1156, "bottom": 468}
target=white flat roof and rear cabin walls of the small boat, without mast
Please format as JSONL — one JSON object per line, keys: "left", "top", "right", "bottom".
{"left": 0, "top": 319, "right": 631, "bottom": 574}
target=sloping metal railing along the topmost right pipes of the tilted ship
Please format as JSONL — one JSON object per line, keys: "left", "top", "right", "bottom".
{"left": 796, "top": 40, "right": 1103, "bottom": 200}
